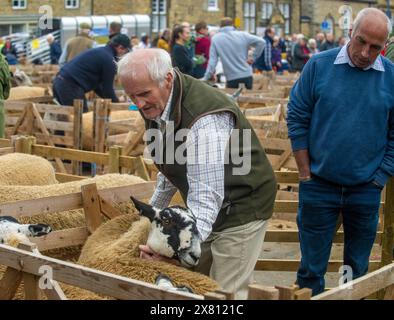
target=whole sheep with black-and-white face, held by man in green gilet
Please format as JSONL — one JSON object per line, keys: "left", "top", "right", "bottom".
{"left": 63, "top": 200, "right": 219, "bottom": 299}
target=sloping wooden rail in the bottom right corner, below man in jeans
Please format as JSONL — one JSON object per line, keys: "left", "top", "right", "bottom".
{"left": 312, "top": 263, "right": 394, "bottom": 300}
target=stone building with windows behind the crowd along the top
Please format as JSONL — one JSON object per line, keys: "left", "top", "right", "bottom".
{"left": 0, "top": 0, "right": 394, "bottom": 37}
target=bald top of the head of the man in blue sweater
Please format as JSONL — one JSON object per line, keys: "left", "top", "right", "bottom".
{"left": 352, "top": 8, "right": 392, "bottom": 39}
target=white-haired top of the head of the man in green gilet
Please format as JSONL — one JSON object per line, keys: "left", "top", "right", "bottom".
{"left": 118, "top": 48, "right": 173, "bottom": 86}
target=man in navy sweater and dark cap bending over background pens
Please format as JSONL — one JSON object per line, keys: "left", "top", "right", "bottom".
{"left": 53, "top": 34, "right": 131, "bottom": 112}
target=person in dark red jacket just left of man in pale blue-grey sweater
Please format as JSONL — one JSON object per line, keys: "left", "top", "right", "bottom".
{"left": 193, "top": 21, "right": 211, "bottom": 79}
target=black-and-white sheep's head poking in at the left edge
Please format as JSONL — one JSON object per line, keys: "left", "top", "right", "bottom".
{"left": 0, "top": 216, "right": 52, "bottom": 243}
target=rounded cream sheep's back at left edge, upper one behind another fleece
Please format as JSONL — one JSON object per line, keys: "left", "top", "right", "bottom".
{"left": 0, "top": 153, "right": 58, "bottom": 186}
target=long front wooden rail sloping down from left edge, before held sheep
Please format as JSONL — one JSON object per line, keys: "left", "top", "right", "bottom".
{"left": 0, "top": 245, "right": 203, "bottom": 300}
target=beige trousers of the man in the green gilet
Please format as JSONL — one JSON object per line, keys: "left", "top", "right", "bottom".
{"left": 194, "top": 220, "right": 268, "bottom": 300}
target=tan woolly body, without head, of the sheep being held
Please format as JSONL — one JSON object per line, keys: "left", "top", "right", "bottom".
{"left": 63, "top": 214, "right": 219, "bottom": 300}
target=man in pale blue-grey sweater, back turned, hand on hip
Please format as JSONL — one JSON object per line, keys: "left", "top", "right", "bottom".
{"left": 203, "top": 18, "right": 265, "bottom": 89}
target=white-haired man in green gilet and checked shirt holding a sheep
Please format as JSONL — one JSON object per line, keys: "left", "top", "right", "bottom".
{"left": 119, "top": 49, "right": 277, "bottom": 299}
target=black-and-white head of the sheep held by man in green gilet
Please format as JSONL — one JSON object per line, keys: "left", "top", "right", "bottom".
{"left": 130, "top": 197, "right": 201, "bottom": 268}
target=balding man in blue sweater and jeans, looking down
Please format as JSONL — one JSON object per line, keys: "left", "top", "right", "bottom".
{"left": 287, "top": 8, "right": 394, "bottom": 295}
